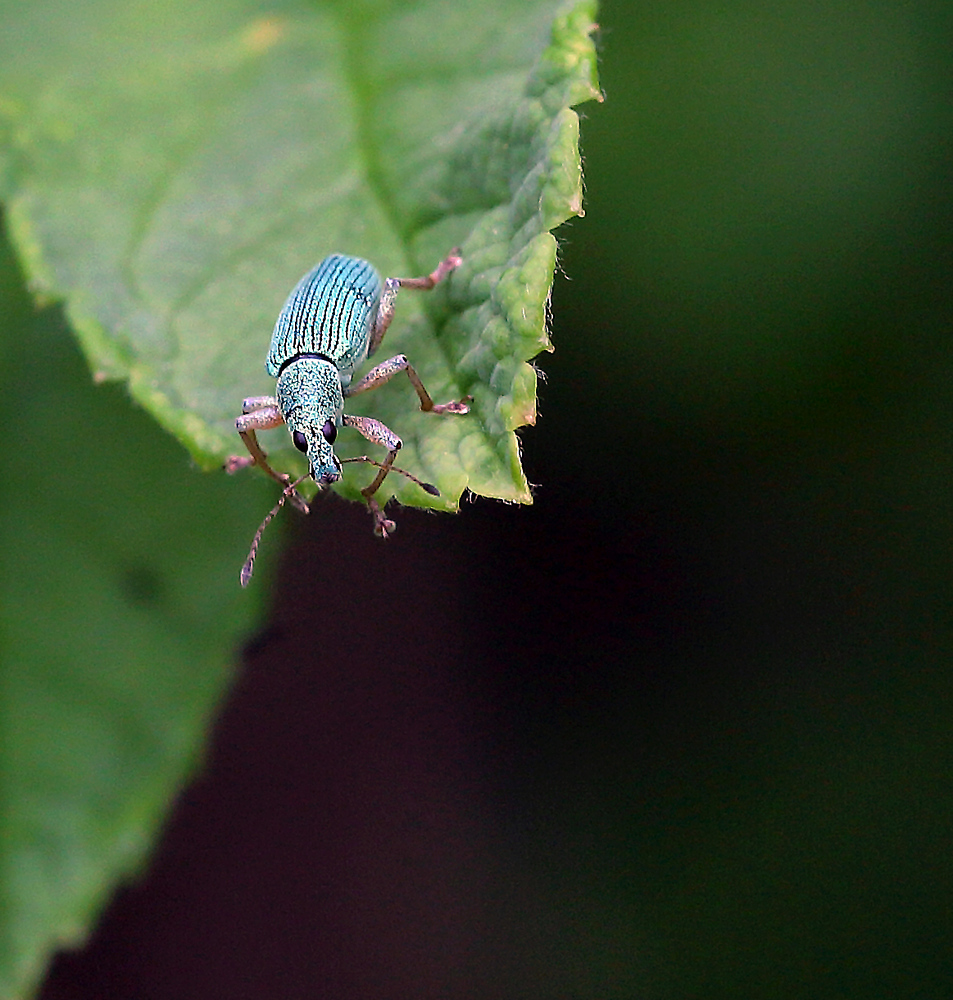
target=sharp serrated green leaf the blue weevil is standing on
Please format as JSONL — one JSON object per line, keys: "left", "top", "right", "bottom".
{"left": 0, "top": 0, "right": 598, "bottom": 509}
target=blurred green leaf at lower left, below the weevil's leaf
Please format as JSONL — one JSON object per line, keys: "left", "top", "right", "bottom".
{"left": 0, "top": 227, "right": 275, "bottom": 1000}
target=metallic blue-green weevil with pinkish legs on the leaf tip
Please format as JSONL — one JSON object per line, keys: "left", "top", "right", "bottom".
{"left": 225, "top": 250, "right": 469, "bottom": 587}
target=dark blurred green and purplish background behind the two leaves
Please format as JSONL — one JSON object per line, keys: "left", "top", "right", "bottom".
{"left": 43, "top": 0, "right": 953, "bottom": 1000}
